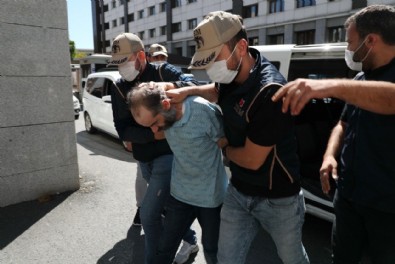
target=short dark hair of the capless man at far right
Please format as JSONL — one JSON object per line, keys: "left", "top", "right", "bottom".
{"left": 344, "top": 5, "right": 395, "bottom": 45}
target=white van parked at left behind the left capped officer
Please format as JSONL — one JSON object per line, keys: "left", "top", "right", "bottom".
{"left": 82, "top": 70, "right": 130, "bottom": 149}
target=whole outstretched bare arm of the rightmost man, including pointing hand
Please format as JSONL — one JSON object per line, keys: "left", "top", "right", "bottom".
{"left": 272, "top": 79, "right": 395, "bottom": 115}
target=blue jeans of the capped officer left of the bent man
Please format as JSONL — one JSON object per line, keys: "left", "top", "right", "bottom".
{"left": 139, "top": 155, "right": 196, "bottom": 264}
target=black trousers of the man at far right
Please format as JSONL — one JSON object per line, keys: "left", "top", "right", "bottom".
{"left": 332, "top": 192, "right": 395, "bottom": 264}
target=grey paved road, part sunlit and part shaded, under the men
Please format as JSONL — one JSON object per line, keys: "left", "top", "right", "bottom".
{"left": 0, "top": 116, "right": 331, "bottom": 264}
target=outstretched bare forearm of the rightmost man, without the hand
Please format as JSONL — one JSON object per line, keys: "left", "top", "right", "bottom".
{"left": 328, "top": 80, "right": 395, "bottom": 114}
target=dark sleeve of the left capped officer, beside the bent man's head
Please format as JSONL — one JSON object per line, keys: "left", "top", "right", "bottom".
{"left": 111, "top": 82, "right": 154, "bottom": 144}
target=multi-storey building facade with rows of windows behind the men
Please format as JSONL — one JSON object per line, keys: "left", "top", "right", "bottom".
{"left": 92, "top": 0, "right": 395, "bottom": 57}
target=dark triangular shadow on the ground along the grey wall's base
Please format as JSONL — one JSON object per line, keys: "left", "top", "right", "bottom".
{"left": 0, "top": 192, "right": 73, "bottom": 250}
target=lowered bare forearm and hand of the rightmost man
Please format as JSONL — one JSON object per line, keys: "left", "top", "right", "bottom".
{"left": 320, "top": 121, "right": 345, "bottom": 194}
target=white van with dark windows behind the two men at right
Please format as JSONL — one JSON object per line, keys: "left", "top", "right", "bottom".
{"left": 255, "top": 43, "right": 356, "bottom": 221}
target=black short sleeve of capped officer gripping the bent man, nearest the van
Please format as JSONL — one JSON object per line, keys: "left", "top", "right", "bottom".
{"left": 247, "top": 85, "right": 294, "bottom": 146}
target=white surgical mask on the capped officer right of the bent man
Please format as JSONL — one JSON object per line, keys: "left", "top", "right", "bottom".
{"left": 206, "top": 46, "right": 242, "bottom": 83}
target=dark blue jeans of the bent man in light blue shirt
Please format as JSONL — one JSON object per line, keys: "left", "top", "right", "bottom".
{"left": 154, "top": 196, "right": 221, "bottom": 264}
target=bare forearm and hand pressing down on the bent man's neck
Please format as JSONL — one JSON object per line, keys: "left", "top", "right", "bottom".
{"left": 166, "top": 83, "right": 218, "bottom": 103}
